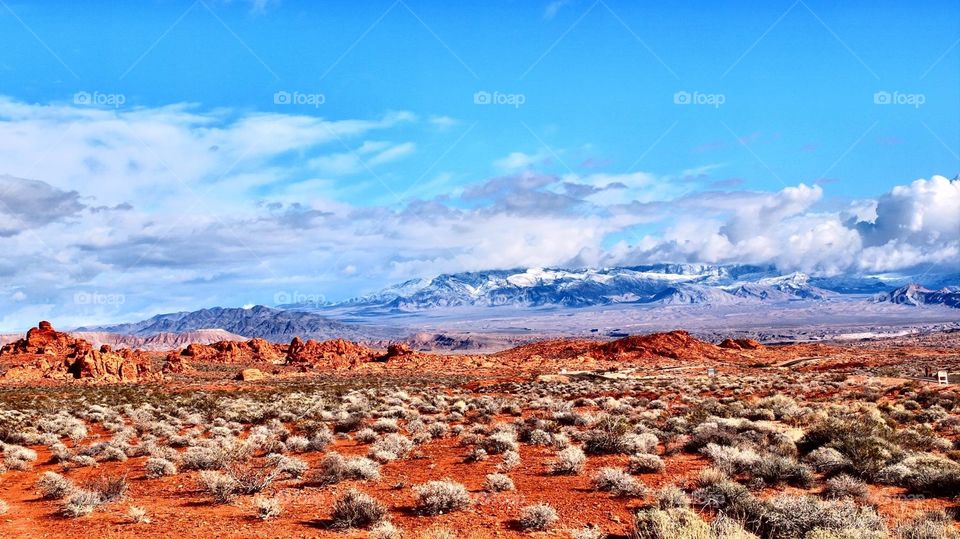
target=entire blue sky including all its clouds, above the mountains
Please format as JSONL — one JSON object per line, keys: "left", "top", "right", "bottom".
{"left": 0, "top": 0, "right": 960, "bottom": 327}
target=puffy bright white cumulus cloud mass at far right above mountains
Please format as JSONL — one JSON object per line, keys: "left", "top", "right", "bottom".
{"left": 603, "top": 176, "right": 960, "bottom": 275}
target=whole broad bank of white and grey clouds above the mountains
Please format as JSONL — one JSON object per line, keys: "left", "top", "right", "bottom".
{"left": 0, "top": 99, "right": 960, "bottom": 329}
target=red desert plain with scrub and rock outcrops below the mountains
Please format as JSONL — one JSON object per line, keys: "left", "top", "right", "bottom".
{"left": 0, "top": 274, "right": 960, "bottom": 538}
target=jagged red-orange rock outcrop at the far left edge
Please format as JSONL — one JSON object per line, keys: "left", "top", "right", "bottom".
{"left": 0, "top": 321, "right": 159, "bottom": 382}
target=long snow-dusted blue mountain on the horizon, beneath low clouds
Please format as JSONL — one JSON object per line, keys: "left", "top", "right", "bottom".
{"left": 283, "top": 264, "right": 848, "bottom": 314}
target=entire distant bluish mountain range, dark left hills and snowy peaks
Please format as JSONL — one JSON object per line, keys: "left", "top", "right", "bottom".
{"left": 77, "top": 264, "right": 960, "bottom": 342}
